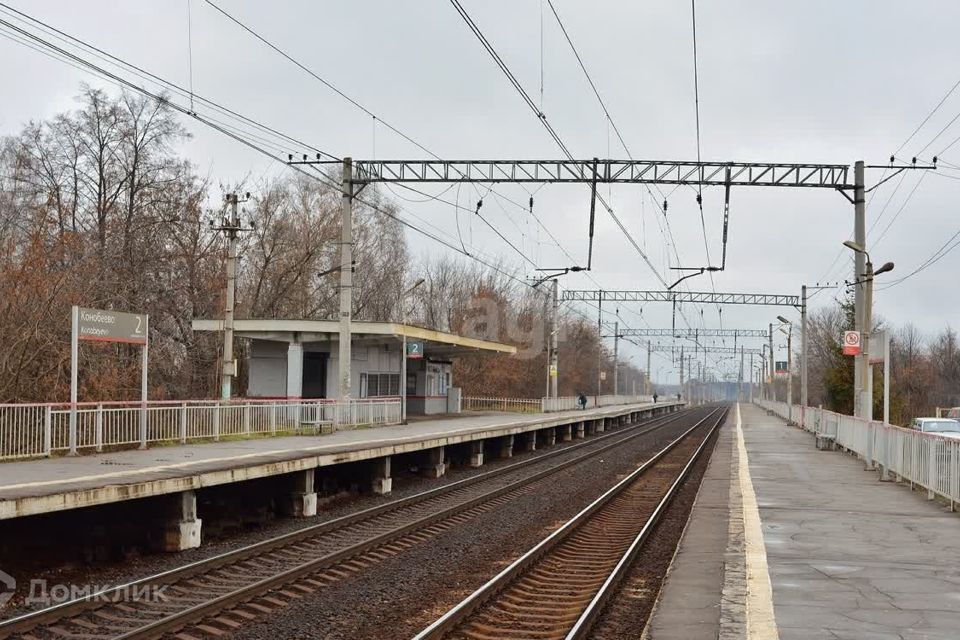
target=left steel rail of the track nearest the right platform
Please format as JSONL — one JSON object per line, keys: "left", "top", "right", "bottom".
{"left": 413, "top": 407, "right": 727, "bottom": 640}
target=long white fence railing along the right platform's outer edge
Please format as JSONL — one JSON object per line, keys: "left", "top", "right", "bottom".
{"left": 757, "top": 401, "right": 960, "bottom": 507}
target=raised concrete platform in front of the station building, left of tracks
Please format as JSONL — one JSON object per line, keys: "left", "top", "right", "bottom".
{"left": 0, "top": 402, "right": 678, "bottom": 520}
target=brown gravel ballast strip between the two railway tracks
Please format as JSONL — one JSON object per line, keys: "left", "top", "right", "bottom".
{"left": 228, "top": 416, "right": 700, "bottom": 640}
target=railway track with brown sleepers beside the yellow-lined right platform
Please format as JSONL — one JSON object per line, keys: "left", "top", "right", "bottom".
{"left": 415, "top": 408, "right": 727, "bottom": 640}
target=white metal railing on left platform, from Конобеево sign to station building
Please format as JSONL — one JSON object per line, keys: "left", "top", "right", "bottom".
{"left": 0, "top": 397, "right": 401, "bottom": 460}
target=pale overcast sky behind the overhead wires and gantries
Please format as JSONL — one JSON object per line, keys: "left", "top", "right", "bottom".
{"left": 0, "top": 0, "right": 960, "bottom": 379}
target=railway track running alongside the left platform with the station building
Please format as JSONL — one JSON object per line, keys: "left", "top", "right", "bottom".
{"left": 0, "top": 409, "right": 703, "bottom": 640}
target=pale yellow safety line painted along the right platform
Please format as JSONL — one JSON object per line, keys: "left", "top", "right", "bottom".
{"left": 737, "top": 402, "right": 780, "bottom": 640}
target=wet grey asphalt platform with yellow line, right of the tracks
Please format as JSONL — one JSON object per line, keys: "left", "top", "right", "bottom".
{"left": 645, "top": 405, "right": 960, "bottom": 640}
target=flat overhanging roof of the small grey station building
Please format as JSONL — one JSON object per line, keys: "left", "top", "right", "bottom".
{"left": 193, "top": 318, "right": 517, "bottom": 357}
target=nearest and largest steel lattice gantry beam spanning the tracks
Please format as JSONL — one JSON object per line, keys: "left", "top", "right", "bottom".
{"left": 328, "top": 159, "right": 854, "bottom": 190}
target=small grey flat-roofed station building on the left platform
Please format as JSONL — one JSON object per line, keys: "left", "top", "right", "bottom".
{"left": 193, "top": 319, "right": 516, "bottom": 415}
